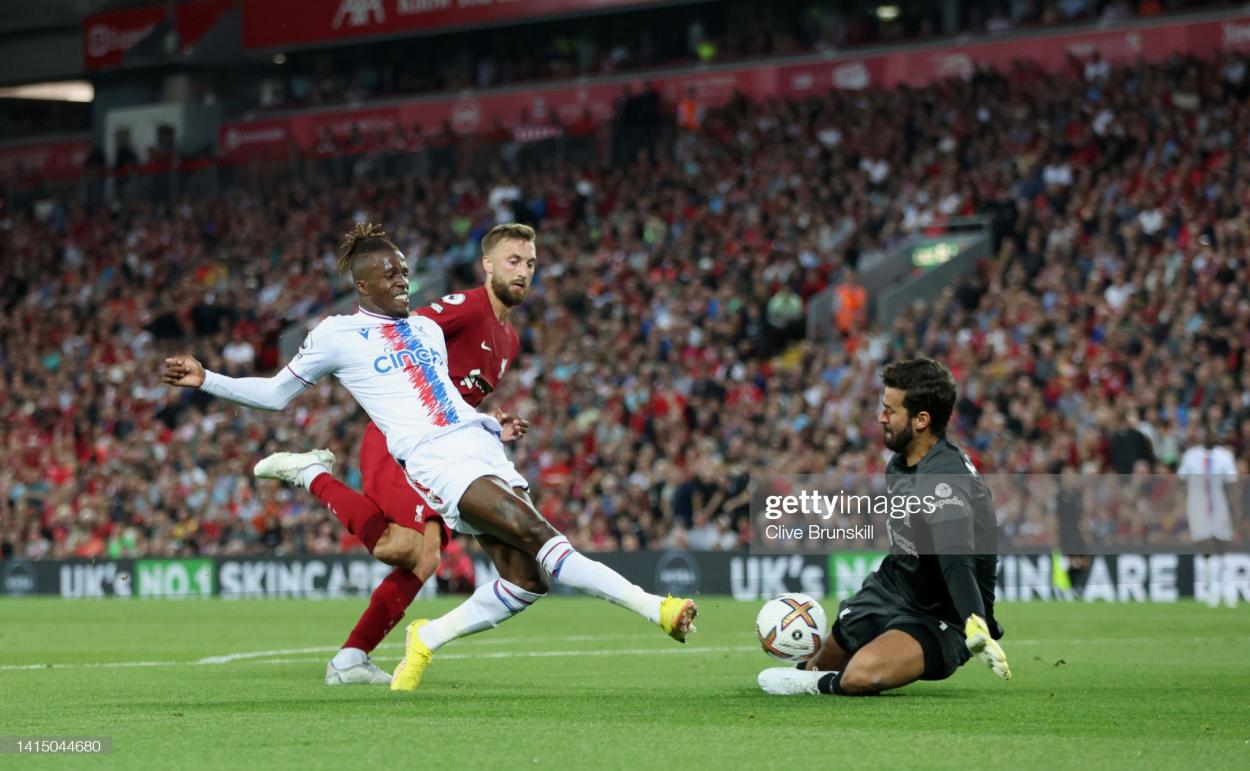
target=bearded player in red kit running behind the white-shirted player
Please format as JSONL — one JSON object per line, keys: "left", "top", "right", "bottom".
{"left": 255, "top": 224, "right": 535, "bottom": 685}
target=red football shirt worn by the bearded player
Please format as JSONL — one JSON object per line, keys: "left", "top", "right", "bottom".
{"left": 415, "top": 286, "right": 521, "bottom": 407}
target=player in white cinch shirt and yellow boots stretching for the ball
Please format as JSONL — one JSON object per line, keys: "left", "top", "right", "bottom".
{"left": 163, "top": 221, "right": 698, "bottom": 691}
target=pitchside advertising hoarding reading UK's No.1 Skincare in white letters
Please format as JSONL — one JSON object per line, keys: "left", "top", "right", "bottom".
{"left": 0, "top": 550, "right": 1250, "bottom": 604}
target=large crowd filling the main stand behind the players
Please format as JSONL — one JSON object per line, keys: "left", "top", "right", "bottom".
{"left": 0, "top": 48, "right": 1250, "bottom": 559}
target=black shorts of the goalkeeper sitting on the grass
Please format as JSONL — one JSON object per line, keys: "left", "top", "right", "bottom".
{"left": 831, "top": 582, "right": 970, "bottom": 680}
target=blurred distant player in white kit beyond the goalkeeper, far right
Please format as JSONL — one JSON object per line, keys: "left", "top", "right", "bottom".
{"left": 1176, "top": 429, "right": 1238, "bottom": 607}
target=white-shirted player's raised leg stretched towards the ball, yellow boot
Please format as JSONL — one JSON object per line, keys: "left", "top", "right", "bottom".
{"left": 459, "top": 476, "right": 699, "bottom": 642}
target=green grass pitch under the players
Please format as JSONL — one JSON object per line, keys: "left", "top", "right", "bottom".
{"left": 0, "top": 597, "right": 1250, "bottom": 771}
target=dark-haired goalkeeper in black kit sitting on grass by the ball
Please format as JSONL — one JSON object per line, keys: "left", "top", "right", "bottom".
{"left": 759, "top": 359, "right": 1011, "bottom": 696}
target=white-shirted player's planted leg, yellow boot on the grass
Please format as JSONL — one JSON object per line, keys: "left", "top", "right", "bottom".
{"left": 391, "top": 535, "right": 546, "bottom": 691}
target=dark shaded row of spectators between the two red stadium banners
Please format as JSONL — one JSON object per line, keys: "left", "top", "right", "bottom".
{"left": 236, "top": 0, "right": 1230, "bottom": 114}
